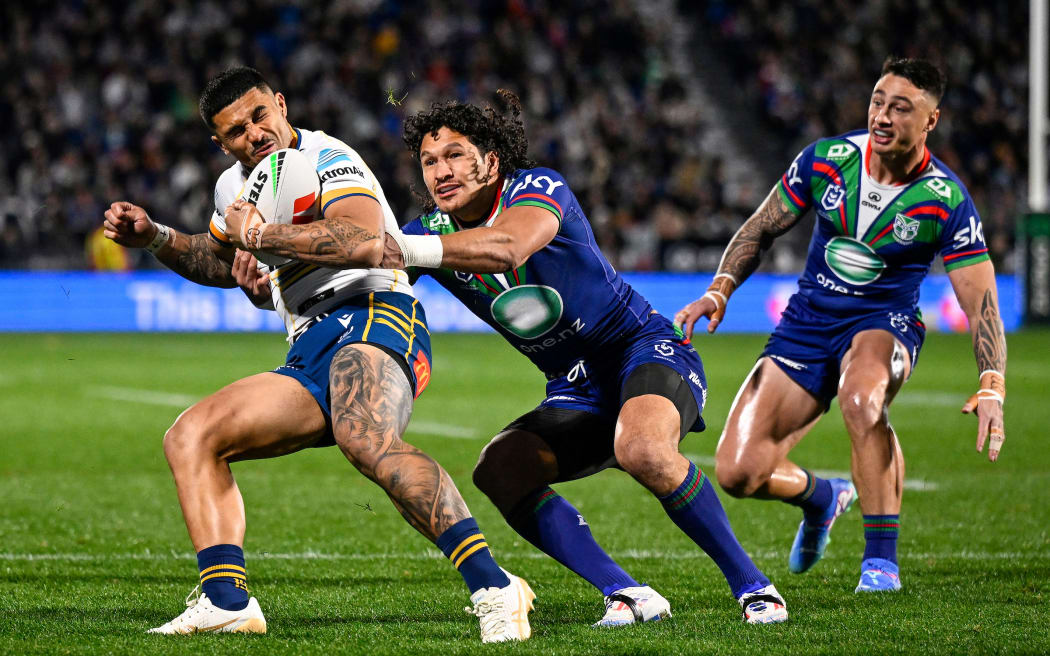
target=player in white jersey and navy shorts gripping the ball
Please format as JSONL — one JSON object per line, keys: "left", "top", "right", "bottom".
{"left": 104, "top": 67, "right": 534, "bottom": 642}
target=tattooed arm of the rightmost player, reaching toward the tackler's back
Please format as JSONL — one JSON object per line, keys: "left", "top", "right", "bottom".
{"left": 674, "top": 187, "right": 801, "bottom": 339}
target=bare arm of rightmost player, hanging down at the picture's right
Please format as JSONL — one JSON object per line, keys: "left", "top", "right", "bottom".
{"left": 948, "top": 260, "right": 1006, "bottom": 462}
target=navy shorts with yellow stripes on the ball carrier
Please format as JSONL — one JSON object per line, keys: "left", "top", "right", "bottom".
{"left": 274, "top": 292, "right": 431, "bottom": 420}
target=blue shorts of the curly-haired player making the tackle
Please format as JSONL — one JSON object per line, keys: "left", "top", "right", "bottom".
{"left": 540, "top": 313, "right": 708, "bottom": 432}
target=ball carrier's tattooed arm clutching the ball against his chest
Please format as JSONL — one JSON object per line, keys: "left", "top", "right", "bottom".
{"left": 224, "top": 196, "right": 383, "bottom": 269}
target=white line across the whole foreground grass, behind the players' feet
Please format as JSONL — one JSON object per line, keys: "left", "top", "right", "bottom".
{"left": 0, "top": 549, "right": 1050, "bottom": 563}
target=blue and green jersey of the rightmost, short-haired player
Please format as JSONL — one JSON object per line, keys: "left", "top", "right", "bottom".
{"left": 776, "top": 130, "right": 988, "bottom": 314}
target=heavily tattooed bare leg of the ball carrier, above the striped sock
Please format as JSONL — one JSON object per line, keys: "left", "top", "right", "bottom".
{"left": 331, "top": 346, "right": 470, "bottom": 542}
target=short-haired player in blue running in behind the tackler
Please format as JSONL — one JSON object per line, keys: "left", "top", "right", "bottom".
{"left": 675, "top": 58, "right": 1006, "bottom": 592}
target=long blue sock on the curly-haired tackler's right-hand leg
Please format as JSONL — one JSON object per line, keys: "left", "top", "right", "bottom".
{"left": 659, "top": 463, "right": 770, "bottom": 597}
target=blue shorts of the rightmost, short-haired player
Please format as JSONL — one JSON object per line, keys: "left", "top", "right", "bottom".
{"left": 759, "top": 294, "right": 926, "bottom": 405}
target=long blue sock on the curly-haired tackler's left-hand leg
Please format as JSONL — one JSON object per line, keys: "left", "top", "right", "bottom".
{"left": 506, "top": 486, "right": 639, "bottom": 596}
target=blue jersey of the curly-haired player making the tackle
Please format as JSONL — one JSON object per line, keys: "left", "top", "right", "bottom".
{"left": 402, "top": 168, "right": 653, "bottom": 375}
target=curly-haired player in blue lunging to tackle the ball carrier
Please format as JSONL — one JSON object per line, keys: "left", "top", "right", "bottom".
{"left": 384, "top": 91, "right": 788, "bottom": 627}
